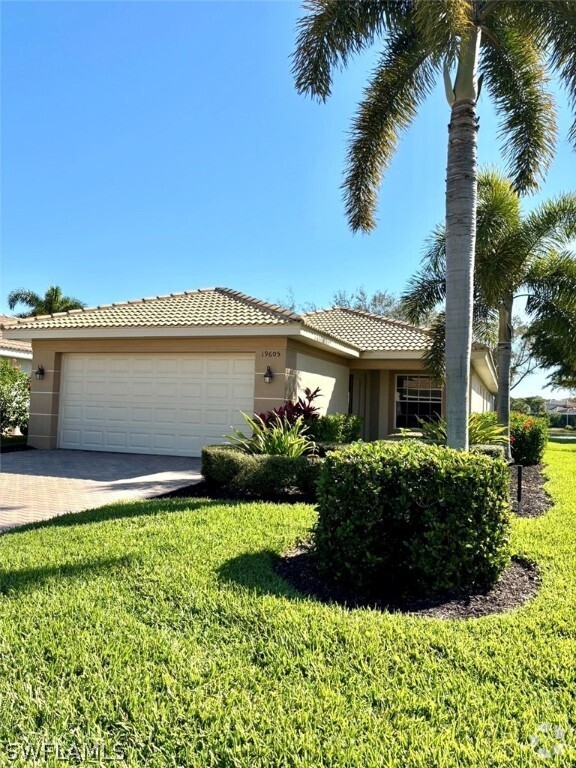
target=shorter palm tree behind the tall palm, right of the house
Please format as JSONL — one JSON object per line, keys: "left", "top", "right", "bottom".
{"left": 402, "top": 171, "right": 576, "bottom": 452}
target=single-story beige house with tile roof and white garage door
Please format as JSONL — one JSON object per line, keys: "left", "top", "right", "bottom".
{"left": 6, "top": 288, "right": 496, "bottom": 456}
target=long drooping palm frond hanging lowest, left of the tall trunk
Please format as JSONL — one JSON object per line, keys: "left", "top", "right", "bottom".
{"left": 342, "top": 25, "right": 440, "bottom": 232}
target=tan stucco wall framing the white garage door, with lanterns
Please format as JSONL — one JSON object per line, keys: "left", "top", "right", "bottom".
{"left": 28, "top": 336, "right": 291, "bottom": 448}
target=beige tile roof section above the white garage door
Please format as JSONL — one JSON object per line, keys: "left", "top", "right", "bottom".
{"left": 2, "top": 288, "right": 302, "bottom": 330}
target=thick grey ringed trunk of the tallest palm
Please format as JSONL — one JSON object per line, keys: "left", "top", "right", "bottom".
{"left": 446, "top": 29, "right": 480, "bottom": 450}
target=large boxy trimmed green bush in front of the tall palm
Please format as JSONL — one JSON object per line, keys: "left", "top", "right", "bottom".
{"left": 314, "top": 440, "right": 510, "bottom": 597}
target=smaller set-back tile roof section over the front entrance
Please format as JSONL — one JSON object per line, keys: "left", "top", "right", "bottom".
{"left": 303, "top": 307, "right": 430, "bottom": 352}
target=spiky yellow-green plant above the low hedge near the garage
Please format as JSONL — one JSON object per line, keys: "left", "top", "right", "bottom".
{"left": 225, "top": 413, "right": 316, "bottom": 458}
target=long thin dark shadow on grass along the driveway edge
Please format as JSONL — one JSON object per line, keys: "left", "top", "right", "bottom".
{"left": 2, "top": 499, "right": 230, "bottom": 536}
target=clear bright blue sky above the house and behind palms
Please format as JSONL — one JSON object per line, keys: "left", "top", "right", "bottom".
{"left": 0, "top": 0, "right": 574, "bottom": 396}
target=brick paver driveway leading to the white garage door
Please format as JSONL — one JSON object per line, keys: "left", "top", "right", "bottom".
{"left": 0, "top": 450, "right": 201, "bottom": 532}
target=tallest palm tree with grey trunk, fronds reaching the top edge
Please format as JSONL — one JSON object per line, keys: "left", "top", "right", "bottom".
{"left": 294, "top": 0, "right": 576, "bottom": 448}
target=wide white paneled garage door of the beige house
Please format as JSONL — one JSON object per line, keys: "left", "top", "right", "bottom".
{"left": 58, "top": 353, "right": 254, "bottom": 456}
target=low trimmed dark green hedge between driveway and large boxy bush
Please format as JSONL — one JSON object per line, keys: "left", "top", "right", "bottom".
{"left": 202, "top": 445, "right": 323, "bottom": 500}
